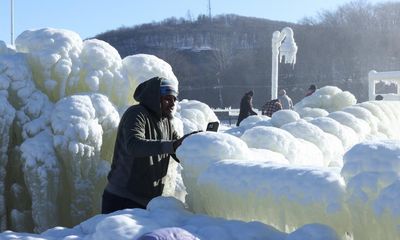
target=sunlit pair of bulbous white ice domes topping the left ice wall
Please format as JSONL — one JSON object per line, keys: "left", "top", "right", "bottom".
{"left": 15, "top": 28, "right": 129, "bottom": 105}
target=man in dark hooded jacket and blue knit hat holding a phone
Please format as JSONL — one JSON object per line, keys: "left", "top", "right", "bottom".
{"left": 102, "top": 77, "right": 192, "bottom": 214}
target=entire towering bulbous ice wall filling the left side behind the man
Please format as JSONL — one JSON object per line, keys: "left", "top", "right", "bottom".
{"left": 0, "top": 28, "right": 200, "bottom": 232}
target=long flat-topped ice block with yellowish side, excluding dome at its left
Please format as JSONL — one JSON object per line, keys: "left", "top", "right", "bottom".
{"left": 198, "top": 160, "right": 349, "bottom": 232}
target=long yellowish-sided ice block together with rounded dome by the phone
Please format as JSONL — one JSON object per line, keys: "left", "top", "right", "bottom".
{"left": 178, "top": 133, "right": 348, "bottom": 236}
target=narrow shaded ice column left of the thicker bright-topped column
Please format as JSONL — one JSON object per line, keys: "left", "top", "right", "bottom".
{"left": 21, "top": 130, "right": 59, "bottom": 232}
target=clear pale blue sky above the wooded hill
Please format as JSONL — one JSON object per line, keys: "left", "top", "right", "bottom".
{"left": 0, "top": 0, "right": 394, "bottom": 43}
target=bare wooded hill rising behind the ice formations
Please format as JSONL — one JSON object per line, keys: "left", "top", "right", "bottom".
{"left": 95, "top": 1, "right": 400, "bottom": 108}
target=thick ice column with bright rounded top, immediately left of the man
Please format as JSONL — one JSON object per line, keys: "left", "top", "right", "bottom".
{"left": 51, "top": 94, "right": 119, "bottom": 224}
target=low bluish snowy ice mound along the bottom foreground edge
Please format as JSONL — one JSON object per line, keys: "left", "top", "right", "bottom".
{"left": 0, "top": 197, "right": 340, "bottom": 240}
